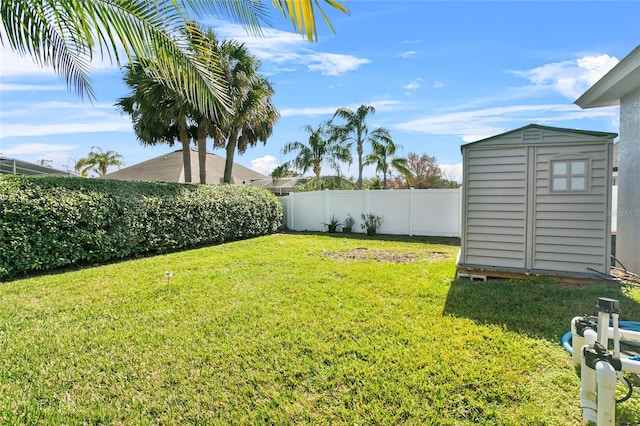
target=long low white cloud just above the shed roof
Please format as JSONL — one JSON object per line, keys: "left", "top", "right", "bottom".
{"left": 390, "top": 104, "right": 617, "bottom": 142}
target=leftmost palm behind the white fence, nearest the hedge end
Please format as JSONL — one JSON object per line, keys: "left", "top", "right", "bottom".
{"left": 282, "top": 123, "right": 351, "bottom": 189}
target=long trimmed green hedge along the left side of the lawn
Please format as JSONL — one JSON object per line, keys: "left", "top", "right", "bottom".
{"left": 0, "top": 175, "right": 282, "bottom": 280}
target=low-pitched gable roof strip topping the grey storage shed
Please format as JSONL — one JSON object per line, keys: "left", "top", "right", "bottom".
{"left": 460, "top": 124, "right": 618, "bottom": 151}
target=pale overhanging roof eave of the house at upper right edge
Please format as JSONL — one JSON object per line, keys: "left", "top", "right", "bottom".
{"left": 574, "top": 45, "right": 640, "bottom": 109}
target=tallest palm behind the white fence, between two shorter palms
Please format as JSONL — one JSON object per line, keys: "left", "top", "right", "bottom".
{"left": 331, "top": 105, "right": 388, "bottom": 189}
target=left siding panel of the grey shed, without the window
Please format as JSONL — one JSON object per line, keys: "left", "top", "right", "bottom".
{"left": 464, "top": 147, "right": 531, "bottom": 268}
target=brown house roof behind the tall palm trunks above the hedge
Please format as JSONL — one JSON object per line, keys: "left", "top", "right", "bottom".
{"left": 102, "top": 148, "right": 266, "bottom": 184}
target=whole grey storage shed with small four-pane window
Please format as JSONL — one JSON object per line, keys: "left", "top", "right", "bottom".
{"left": 457, "top": 124, "right": 617, "bottom": 279}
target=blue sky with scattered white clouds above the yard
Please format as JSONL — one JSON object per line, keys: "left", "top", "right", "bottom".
{"left": 0, "top": 0, "right": 640, "bottom": 182}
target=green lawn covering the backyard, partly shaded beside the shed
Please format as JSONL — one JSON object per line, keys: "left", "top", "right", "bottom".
{"left": 0, "top": 234, "right": 640, "bottom": 425}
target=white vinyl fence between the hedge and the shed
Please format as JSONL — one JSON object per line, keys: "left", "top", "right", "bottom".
{"left": 282, "top": 189, "right": 462, "bottom": 237}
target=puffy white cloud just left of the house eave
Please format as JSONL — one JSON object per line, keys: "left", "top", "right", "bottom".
{"left": 512, "top": 54, "right": 618, "bottom": 100}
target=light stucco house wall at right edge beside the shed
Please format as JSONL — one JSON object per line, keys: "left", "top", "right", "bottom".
{"left": 616, "top": 88, "right": 640, "bottom": 274}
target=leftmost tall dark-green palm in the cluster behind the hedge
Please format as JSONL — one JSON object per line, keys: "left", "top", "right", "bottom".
{"left": 116, "top": 63, "right": 193, "bottom": 182}
